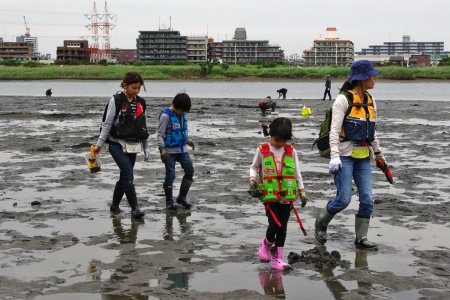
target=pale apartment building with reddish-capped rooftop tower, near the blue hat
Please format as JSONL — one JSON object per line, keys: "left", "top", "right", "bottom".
{"left": 303, "top": 27, "right": 355, "bottom": 66}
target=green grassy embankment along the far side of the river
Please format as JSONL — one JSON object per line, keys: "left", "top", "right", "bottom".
{"left": 0, "top": 65, "right": 450, "bottom": 80}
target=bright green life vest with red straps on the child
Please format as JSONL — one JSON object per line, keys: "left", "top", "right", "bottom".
{"left": 258, "top": 143, "right": 297, "bottom": 202}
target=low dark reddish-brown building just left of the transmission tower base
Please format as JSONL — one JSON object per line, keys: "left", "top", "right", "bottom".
{"left": 56, "top": 40, "right": 91, "bottom": 64}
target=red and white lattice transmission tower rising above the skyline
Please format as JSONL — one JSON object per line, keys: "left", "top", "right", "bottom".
{"left": 81, "top": 1, "right": 116, "bottom": 62}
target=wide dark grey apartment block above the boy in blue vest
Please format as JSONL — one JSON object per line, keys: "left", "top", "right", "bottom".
{"left": 136, "top": 29, "right": 187, "bottom": 64}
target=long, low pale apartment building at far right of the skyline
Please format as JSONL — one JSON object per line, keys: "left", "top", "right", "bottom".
{"left": 356, "top": 35, "right": 445, "bottom": 56}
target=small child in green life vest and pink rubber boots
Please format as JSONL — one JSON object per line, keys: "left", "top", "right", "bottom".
{"left": 249, "top": 118, "right": 308, "bottom": 270}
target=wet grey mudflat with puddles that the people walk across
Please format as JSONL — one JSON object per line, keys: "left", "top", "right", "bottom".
{"left": 0, "top": 92, "right": 450, "bottom": 299}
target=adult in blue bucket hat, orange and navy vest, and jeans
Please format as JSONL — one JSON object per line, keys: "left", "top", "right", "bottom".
{"left": 315, "top": 60, "right": 387, "bottom": 250}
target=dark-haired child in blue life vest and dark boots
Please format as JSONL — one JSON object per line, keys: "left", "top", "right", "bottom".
{"left": 157, "top": 93, "right": 195, "bottom": 210}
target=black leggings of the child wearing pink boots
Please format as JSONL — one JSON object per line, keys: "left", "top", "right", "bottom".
{"left": 265, "top": 202, "right": 291, "bottom": 247}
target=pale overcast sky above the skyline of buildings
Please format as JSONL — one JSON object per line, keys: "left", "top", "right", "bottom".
{"left": 0, "top": 0, "right": 450, "bottom": 57}
